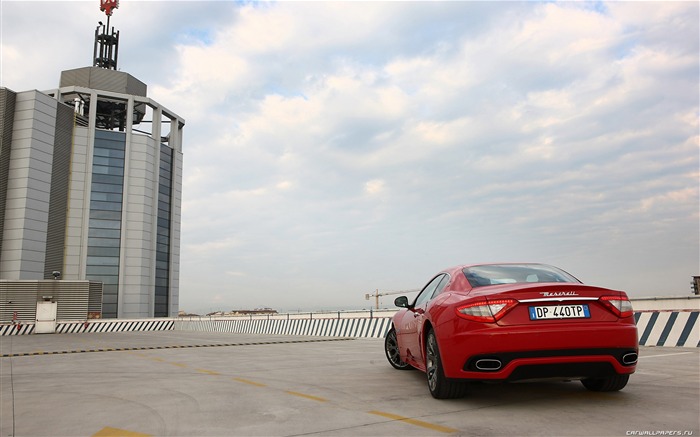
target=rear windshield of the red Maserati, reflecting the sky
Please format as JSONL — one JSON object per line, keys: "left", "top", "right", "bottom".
{"left": 462, "top": 264, "right": 580, "bottom": 288}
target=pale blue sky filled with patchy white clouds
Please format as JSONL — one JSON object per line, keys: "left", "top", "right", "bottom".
{"left": 0, "top": 0, "right": 700, "bottom": 314}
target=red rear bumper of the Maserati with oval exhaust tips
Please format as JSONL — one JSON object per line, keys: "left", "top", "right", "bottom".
{"left": 438, "top": 323, "right": 638, "bottom": 381}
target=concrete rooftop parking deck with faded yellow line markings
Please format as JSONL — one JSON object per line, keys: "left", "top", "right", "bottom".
{"left": 0, "top": 331, "right": 700, "bottom": 436}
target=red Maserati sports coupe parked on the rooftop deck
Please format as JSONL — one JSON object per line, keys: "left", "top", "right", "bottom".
{"left": 384, "top": 264, "right": 639, "bottom": 399}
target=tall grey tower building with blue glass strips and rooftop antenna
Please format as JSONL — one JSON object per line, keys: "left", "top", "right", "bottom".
{"left": 0, "top": 12, "right": 185, "bottom": 318}
